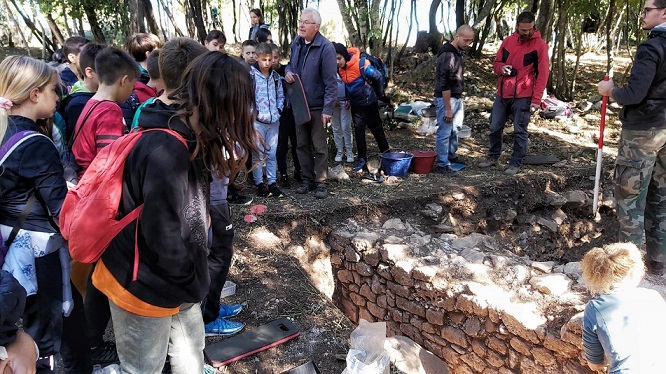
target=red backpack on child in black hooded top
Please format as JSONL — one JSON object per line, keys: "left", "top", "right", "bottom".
{"left": 60, "top": 129, "right": 187, "bottom": 280}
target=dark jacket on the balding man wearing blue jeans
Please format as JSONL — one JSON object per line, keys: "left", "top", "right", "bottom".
{"left": 435, "top": 42, "right": 465, "bottom": 97}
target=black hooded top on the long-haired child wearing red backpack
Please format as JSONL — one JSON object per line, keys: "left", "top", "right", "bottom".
{"left": 98, "top": 100, "right": 210, "bottom": 308}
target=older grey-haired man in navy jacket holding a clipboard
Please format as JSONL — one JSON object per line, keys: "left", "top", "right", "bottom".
{"left": 284, "top": 8, "right": 337, "bottom": 199}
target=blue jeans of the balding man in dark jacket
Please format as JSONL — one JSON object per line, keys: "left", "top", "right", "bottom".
{"left": 434, "top": 97, "right": 465, "bottom": 167}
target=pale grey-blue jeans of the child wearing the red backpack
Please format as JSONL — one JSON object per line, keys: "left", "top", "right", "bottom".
{"left": 109, "top": 300, "right": 205, "bottom": 374}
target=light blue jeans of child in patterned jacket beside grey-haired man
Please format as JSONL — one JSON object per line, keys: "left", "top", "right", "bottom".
{"left": 252, "top": 121, "right": 280, "bottom": 185}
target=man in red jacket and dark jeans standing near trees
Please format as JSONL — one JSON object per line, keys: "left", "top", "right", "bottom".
{"left": 479, "top": 12, "right": 549, "bottom": 175}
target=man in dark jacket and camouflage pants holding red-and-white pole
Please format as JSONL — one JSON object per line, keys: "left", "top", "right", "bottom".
{"left": 598, "top": 0, "right": 666, "bottom": 275}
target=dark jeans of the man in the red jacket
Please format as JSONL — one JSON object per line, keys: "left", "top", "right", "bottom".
{"left": 488, "top": 96, "right": 532, "bottom": 166}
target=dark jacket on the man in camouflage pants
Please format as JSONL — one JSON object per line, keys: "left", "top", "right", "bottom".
{"left": 612, "top": 27, "right": 666, "bottom": 130}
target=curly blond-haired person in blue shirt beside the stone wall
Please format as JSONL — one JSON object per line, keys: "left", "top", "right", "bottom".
{"left": 580, "top": 243, "right": 666, "bottom": 374}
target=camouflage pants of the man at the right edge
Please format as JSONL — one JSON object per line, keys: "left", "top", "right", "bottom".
{"left": 615, "top": 129, "right": 666, "bottom": 262}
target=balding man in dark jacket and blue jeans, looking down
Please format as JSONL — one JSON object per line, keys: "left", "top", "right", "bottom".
{"left": 434, "top": 25, "right": 474, "bottom": 174}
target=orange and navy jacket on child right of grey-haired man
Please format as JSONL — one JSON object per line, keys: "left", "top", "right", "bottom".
{"left": 338, "top": 47, "right": 384, "bottom": 107}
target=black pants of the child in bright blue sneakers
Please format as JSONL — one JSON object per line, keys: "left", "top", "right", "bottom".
{"left": 201, "top": 204, "right": 234, "bottom": 324}
